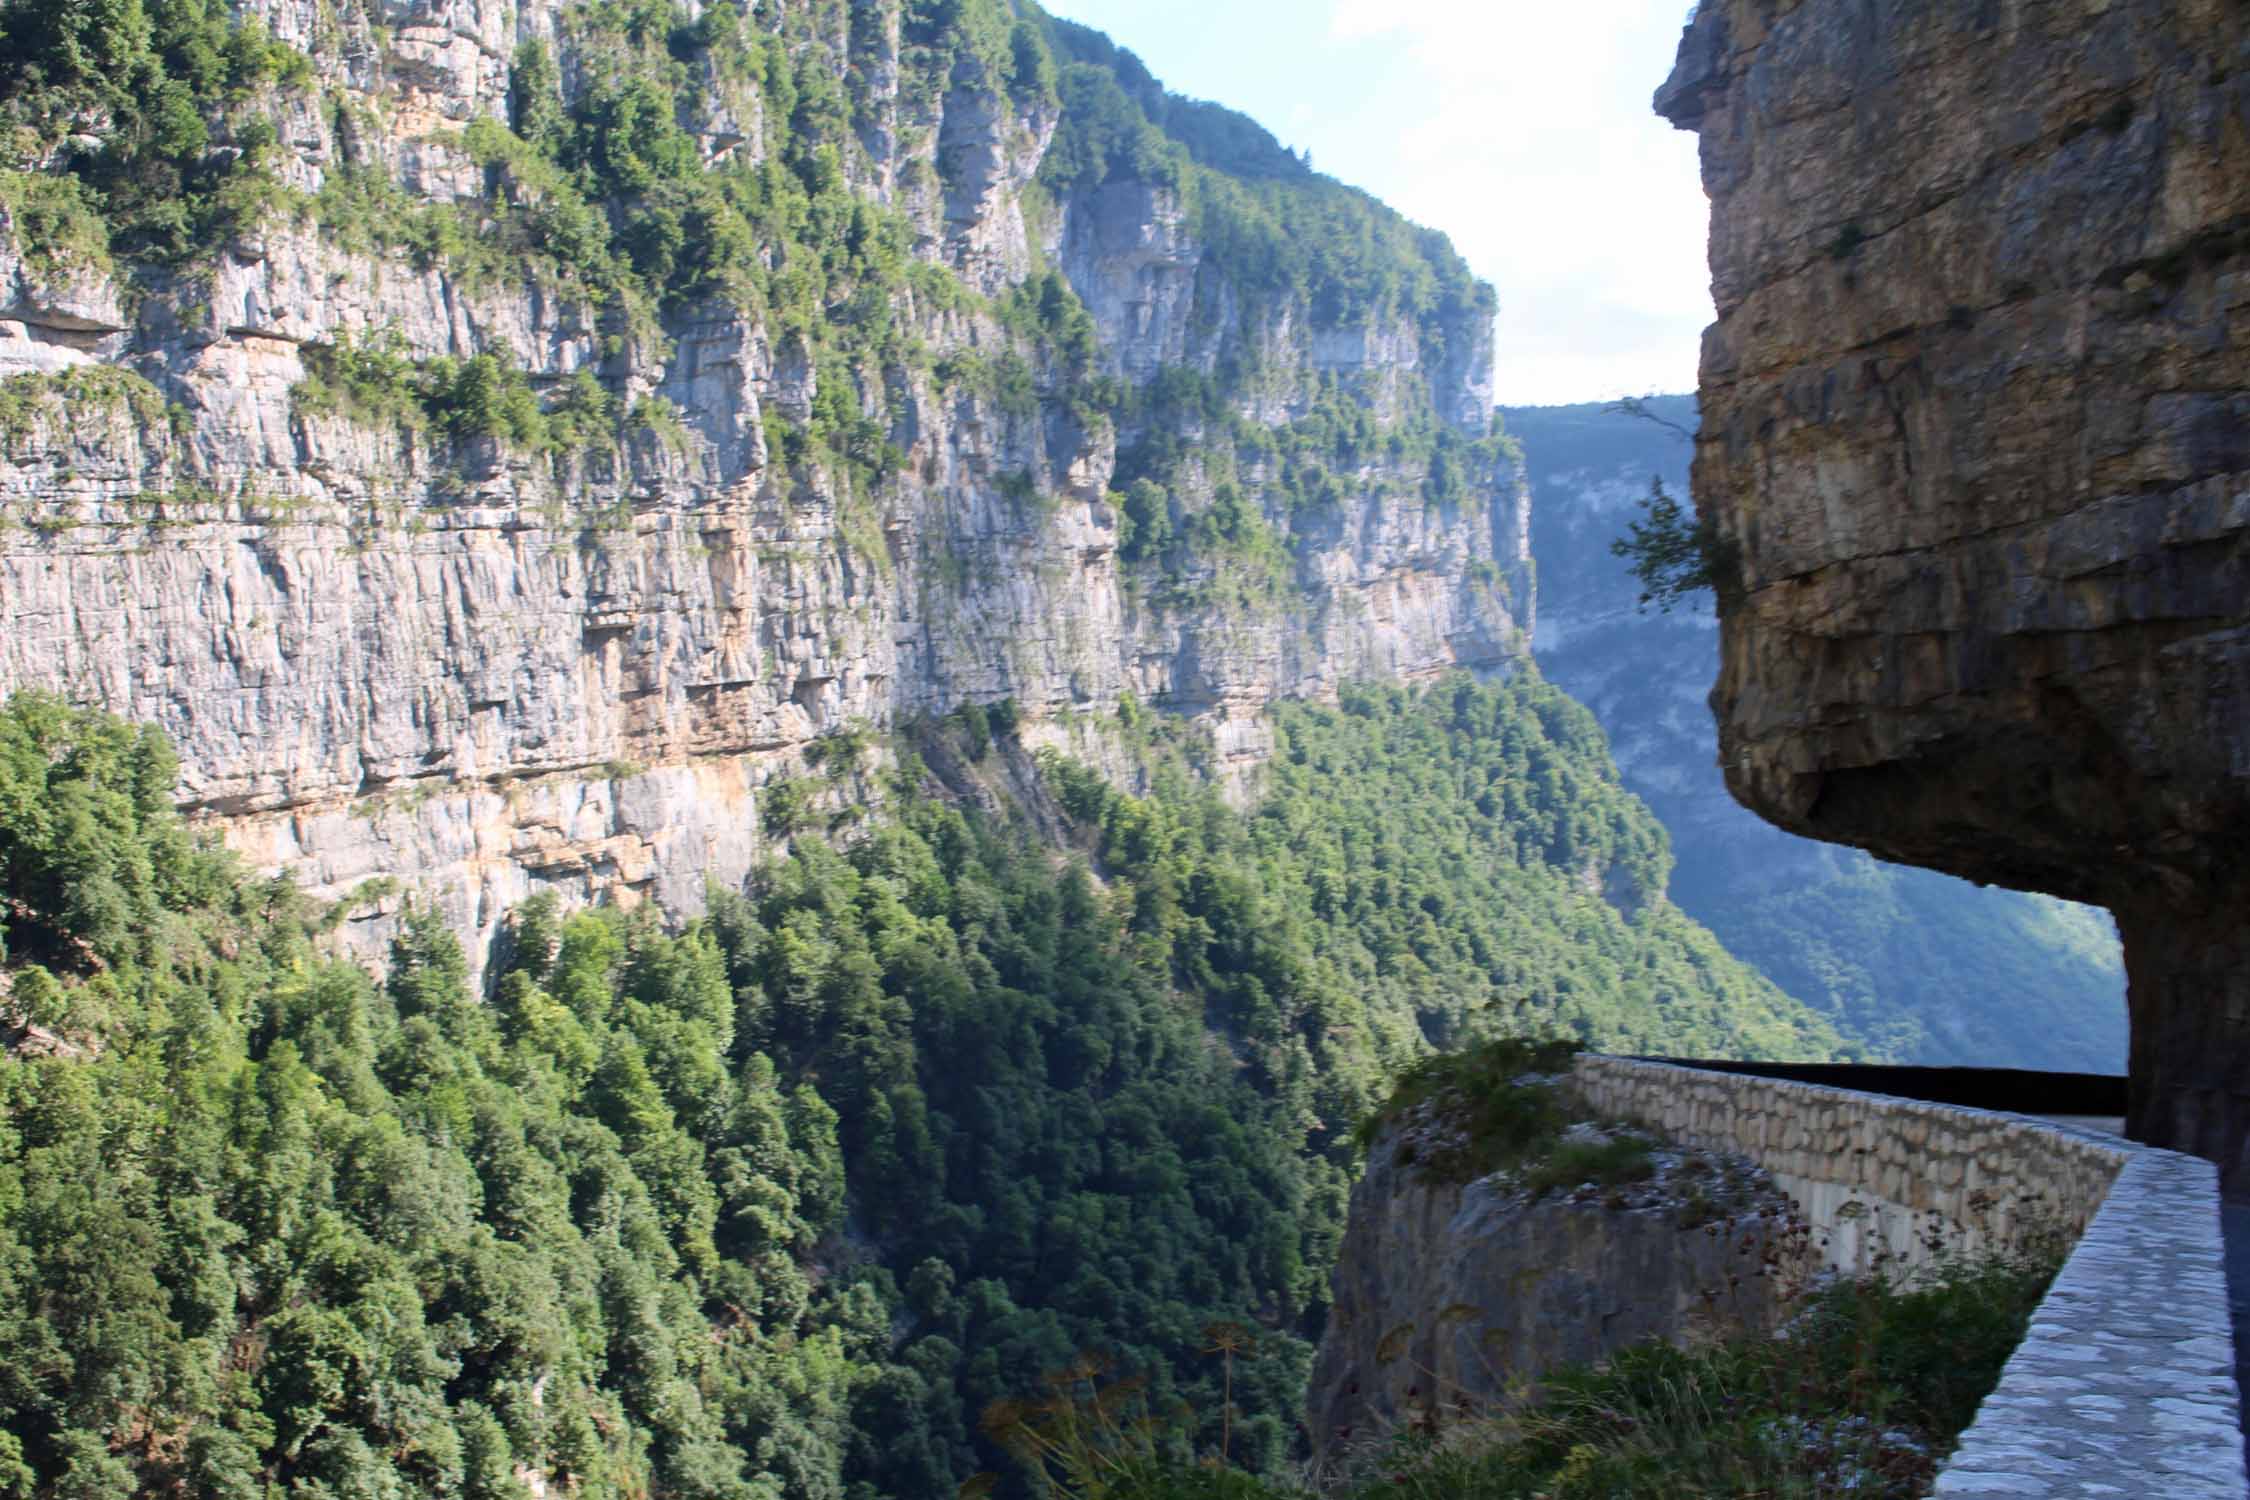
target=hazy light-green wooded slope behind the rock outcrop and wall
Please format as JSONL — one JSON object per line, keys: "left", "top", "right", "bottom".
{"left": 1053, "top": 670, "right": 1836, "bottom": 1083}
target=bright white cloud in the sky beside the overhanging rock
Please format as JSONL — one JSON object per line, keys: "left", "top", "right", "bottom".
{"left": 1328, "top": 0, "right": 1710, "bottom": 400}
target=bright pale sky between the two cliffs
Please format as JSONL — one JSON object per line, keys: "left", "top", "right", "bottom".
{"left": 1042, "top": 0, "right": 1712, "bottom": 405}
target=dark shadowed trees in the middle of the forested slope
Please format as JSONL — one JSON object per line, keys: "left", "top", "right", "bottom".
{"left": 716, "top": 803, "right": 1321, "bottom": 1493}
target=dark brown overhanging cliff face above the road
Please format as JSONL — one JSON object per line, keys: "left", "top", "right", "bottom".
{"left": 1658, "top": 0, "right": 2250, "bottom": 1185}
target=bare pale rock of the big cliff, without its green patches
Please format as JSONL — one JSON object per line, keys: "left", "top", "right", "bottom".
{"left": 0, "top": 0, "right": 1530, "bottom": 967}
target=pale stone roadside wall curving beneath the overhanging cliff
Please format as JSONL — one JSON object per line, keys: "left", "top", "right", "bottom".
{"left": 1575, "top": 1057, "right": 2250, "bottom": 1500}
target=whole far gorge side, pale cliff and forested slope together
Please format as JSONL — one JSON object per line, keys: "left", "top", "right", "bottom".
{"left": 0, "top": 0, "right": 2205, "bottom": 1500}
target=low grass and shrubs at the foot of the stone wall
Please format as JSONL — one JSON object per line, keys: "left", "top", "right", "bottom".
{"left": 1089, "top": 1250, "right": 2059, "bottom": 1500}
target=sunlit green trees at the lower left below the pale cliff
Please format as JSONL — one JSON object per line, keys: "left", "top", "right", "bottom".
{"left": 0, "top": 695, "right": 889, "bottom": 1500}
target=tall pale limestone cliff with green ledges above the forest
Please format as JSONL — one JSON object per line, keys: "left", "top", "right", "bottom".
{"left": 0, "top": 0, "right": 1530, "bottom": 962}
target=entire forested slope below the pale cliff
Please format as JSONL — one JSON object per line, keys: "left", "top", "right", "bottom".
{"left": 0, "top": 672, "right": 1836, "bottom": 1496}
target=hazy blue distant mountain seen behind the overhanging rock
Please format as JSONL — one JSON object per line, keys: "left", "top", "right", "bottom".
{"left": 1505, "top": 396, "right": 2124, "bottom": 1073}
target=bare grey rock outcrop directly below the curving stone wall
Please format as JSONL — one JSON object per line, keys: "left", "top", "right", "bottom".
{"left": 1307, "top": 1124, "right": 1791, "bottom": 1455}
